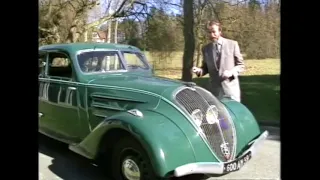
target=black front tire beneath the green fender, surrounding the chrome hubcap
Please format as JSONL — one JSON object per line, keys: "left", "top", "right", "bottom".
{"left": 112, "top": 137, "right": 160, "bottom": 180}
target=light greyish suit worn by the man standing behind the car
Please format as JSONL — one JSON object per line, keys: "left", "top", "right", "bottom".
{"left": 201, "top": 38, "right": 244, "bottom": 101}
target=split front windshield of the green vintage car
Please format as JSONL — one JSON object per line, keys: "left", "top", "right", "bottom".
{"left": 77, "top": 50, "right": 149, "bottom": 74}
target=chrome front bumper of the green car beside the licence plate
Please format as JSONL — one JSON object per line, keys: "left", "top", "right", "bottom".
{"left": 174, "top": 131, "right": 269, "bottom": 177}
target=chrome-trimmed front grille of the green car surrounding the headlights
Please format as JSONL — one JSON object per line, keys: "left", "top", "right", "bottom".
{"left": 175, "top": 87, "right": 236, "bottom": 161}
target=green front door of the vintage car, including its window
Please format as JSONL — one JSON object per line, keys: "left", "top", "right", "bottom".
{"left": 39, "top": 51, "right": 81, "bottom": 143}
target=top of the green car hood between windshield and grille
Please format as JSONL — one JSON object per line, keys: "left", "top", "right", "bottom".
{"left": 88, "top": 73, "right": 184, "bottom": 95}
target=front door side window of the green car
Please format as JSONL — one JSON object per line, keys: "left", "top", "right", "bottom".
{"left": 48, "top": 52, "right": 72, "bottom": 80}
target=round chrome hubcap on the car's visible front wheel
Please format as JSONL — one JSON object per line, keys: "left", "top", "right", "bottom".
{"left": 122, "top": 158, "right": 140, "bottom": 180}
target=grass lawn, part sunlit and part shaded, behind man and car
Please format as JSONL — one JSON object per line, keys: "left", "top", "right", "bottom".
{"left": 151, "top": 59, "right": 280, "bottom": 122}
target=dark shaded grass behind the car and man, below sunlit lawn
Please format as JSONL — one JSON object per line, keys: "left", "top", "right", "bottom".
{"left": 193, "top": 75, "right": 280, "bottom": 121}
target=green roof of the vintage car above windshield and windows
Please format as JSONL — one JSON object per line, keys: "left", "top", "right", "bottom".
{"left": 39, "top": 42, "right": 140, "bottom": 52}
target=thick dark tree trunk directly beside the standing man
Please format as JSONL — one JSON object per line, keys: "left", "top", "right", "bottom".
{"left": 182, "top": 0, "right": 195, "bottom": 81}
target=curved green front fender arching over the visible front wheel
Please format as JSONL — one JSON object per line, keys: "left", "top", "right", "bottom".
{"left": 70, "top": 110, "right": 195, "bottom": 176}
